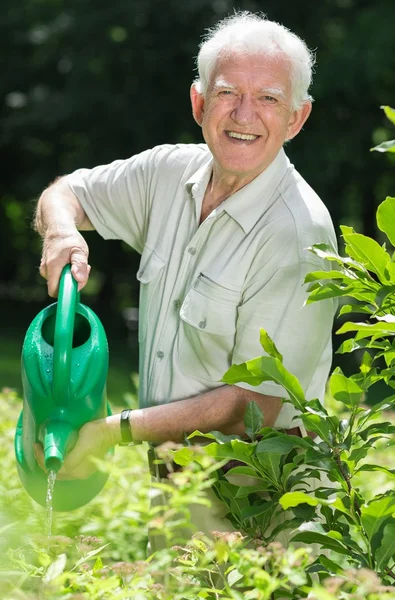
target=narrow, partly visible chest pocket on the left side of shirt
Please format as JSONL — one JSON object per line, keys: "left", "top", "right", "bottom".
{"left": 136, "top": 246, "right": 166, "bottom": 342}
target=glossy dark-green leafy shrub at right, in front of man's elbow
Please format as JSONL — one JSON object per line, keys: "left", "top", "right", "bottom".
{"left": 163, "top": 107, "right": 395, "bottom": 597}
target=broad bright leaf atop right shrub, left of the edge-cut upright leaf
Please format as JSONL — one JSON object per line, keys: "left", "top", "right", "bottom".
{"left": 341, "top": 226, "right": 391, "bottom": 283}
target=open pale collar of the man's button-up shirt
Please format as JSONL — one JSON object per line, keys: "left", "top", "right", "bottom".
{"left": 185, "top": 148, "right": 290, "bottom": 234}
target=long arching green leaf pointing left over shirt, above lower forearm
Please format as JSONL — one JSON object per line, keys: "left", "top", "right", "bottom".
{"left": 221, "top": 356, "right": 306, "bottom": 411}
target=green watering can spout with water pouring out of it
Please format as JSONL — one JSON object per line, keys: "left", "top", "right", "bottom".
{"left": 42, "top": 421, "right": 78, "bottom": 472}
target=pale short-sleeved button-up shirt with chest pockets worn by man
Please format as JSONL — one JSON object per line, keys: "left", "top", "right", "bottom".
{"left": 68, "top": 144, "right": 336, "bottom": 427}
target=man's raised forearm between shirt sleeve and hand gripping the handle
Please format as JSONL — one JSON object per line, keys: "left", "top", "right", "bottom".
{"left": 34, "top": 177, "right": 93, "bottom": 237}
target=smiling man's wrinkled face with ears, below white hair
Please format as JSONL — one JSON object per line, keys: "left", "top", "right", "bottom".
{"left": 191, "top": 54, "right": 311, "bottom": 185}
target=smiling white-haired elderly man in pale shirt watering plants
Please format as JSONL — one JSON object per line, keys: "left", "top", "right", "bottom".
{"left": 37, "top": 13, "right": 336, "bottom": 530}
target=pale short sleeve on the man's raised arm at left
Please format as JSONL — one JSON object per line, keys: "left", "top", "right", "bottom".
{"left": 67, "top": 149, "right": 164, "bottom": 253}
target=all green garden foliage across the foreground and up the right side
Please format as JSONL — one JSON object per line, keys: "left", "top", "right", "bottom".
{"left": 0, "top": 107, "right": 395, "bottom": 600}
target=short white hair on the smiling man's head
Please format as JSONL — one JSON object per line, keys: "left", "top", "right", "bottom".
{"left": 194, "top": 11, "right": 315, "bottom": 110}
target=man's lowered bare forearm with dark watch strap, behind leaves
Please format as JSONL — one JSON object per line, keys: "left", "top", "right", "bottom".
{"left": 106, "top": 386, "right": 281, "bottom": 444}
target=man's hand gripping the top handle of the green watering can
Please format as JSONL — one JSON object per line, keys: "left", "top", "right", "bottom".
{"left": 40, "top": 229, "right": 91, "bottom": 298}
